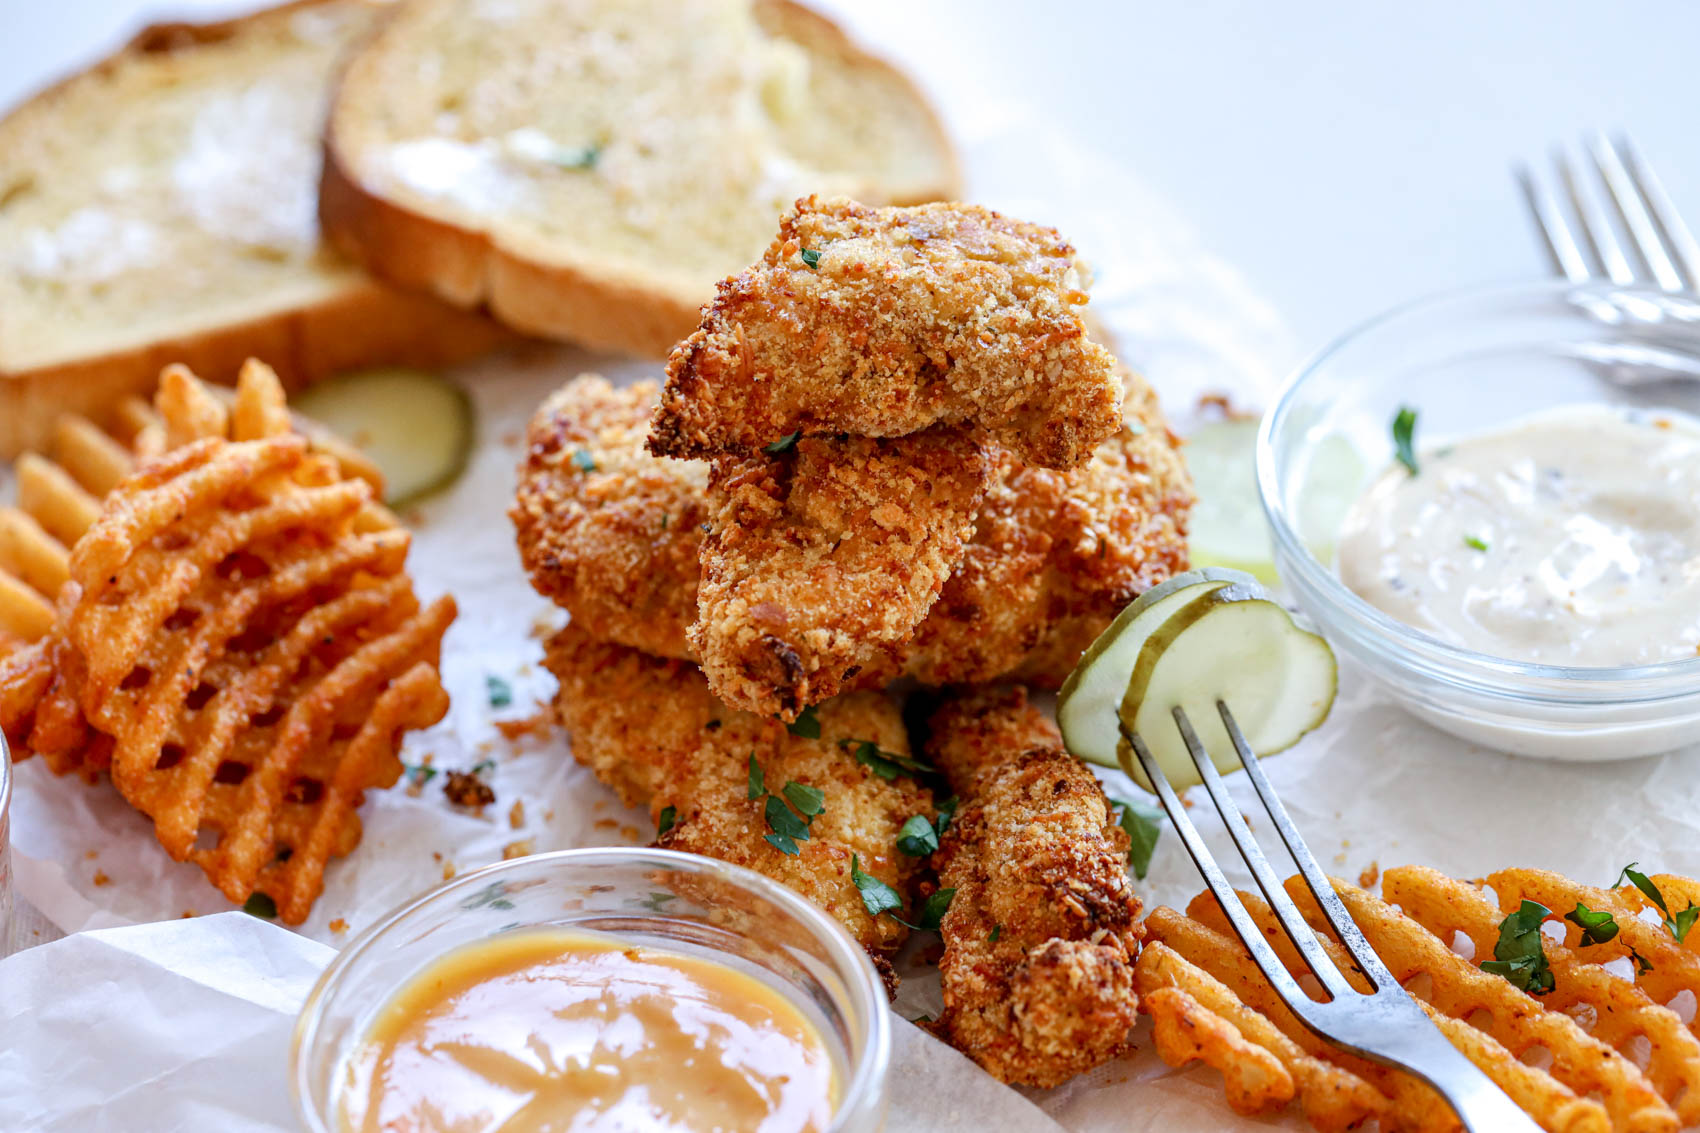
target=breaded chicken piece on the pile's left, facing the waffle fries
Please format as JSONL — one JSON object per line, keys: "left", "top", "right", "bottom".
{"left": 508, "top": 374, "right": 709, "bottom": 657}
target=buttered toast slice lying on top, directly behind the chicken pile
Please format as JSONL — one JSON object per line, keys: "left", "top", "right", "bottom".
{"left": 320, "top": 0, "right": 959, "bottom": 357}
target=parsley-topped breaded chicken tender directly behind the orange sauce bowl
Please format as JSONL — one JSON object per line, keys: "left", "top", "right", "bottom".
{"left": 544, "top": 623, "right": 933, "bottom": 954}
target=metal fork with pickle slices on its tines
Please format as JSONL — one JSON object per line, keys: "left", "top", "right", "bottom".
{"left": 1122, "top": 701, "right": 1540, "bottom": 1133}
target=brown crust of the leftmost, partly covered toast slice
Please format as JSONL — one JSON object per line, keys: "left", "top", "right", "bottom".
{"left": 0, "top": 0, "right": 513, "bottom": 459}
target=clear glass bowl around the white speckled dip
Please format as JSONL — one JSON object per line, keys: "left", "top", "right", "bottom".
{"left": 1258, "top": 281, "right": 1700, "bottom": 760}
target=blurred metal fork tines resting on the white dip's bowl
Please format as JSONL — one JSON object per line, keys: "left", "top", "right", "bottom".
{"left": 1516, "top": 133, "right": 1700, "bottom": 291}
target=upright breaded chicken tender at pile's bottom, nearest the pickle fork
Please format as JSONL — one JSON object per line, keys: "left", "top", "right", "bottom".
{"left": 927, "top": 686, "right": 1144, "bottom": 1085}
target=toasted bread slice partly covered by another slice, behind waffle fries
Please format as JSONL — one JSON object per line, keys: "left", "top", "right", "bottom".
{"left": 0, "top": 0, "right": 500, "bottom": 458}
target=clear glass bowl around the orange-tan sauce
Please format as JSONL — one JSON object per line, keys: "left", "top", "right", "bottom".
{"left": 291, "top": 847, "right": 891, "bottom": 1133}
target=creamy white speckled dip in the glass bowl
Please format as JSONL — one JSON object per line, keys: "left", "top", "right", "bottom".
{"left": 1336, "top": 405, "right": 1700, "bottom": 667}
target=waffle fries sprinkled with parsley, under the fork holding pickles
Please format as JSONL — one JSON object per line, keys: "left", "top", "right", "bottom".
{"left": 1136, "top": 868, "right": 1700, "bottom": 1133}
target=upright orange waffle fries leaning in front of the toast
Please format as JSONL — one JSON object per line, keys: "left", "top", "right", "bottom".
{"left": 0, "top": 362, "right": 454, "bottom": 924}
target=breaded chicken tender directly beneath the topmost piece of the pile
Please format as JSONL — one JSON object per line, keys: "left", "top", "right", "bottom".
{"left": 690, "top": 429, "right": 988, "bottom": 720}
